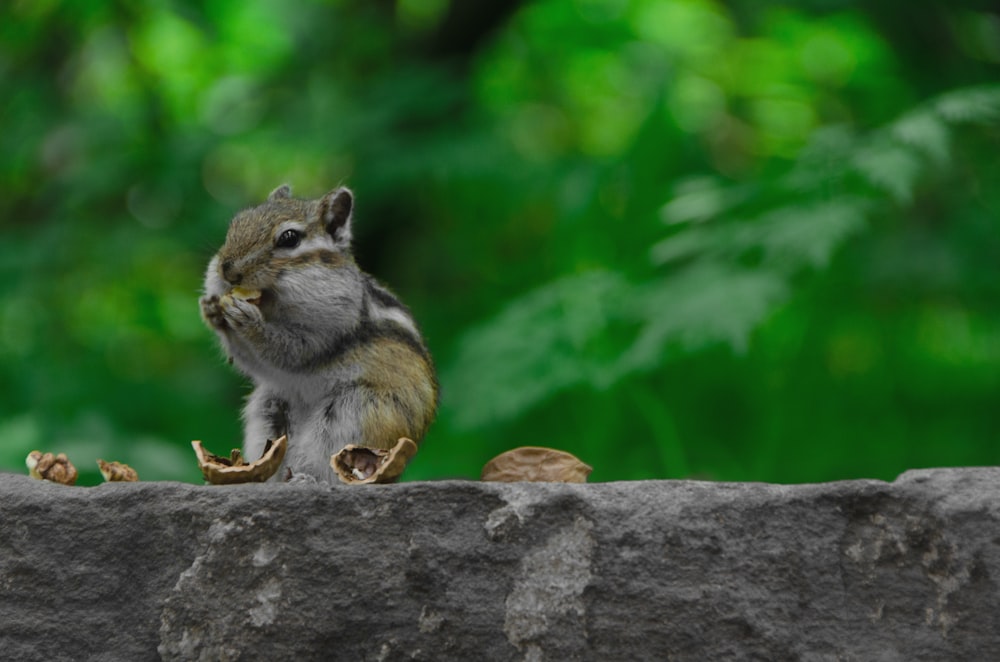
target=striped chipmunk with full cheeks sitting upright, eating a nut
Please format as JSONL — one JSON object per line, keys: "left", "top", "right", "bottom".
{"left": 199, "top": 185, "right": 438, "bottom": 481}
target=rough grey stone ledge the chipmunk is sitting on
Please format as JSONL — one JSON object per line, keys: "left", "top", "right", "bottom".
{"left": 0, "top": 469, "right": 1000, "bottom": 661}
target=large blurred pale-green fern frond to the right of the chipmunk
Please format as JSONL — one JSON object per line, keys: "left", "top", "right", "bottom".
{"left": 443, "top": 86, "right": 1000, "bottom": 429}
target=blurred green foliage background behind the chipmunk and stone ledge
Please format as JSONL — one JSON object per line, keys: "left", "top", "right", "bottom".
{"left": 0, "top": 0, "right": 1000, "bottom": 483}
